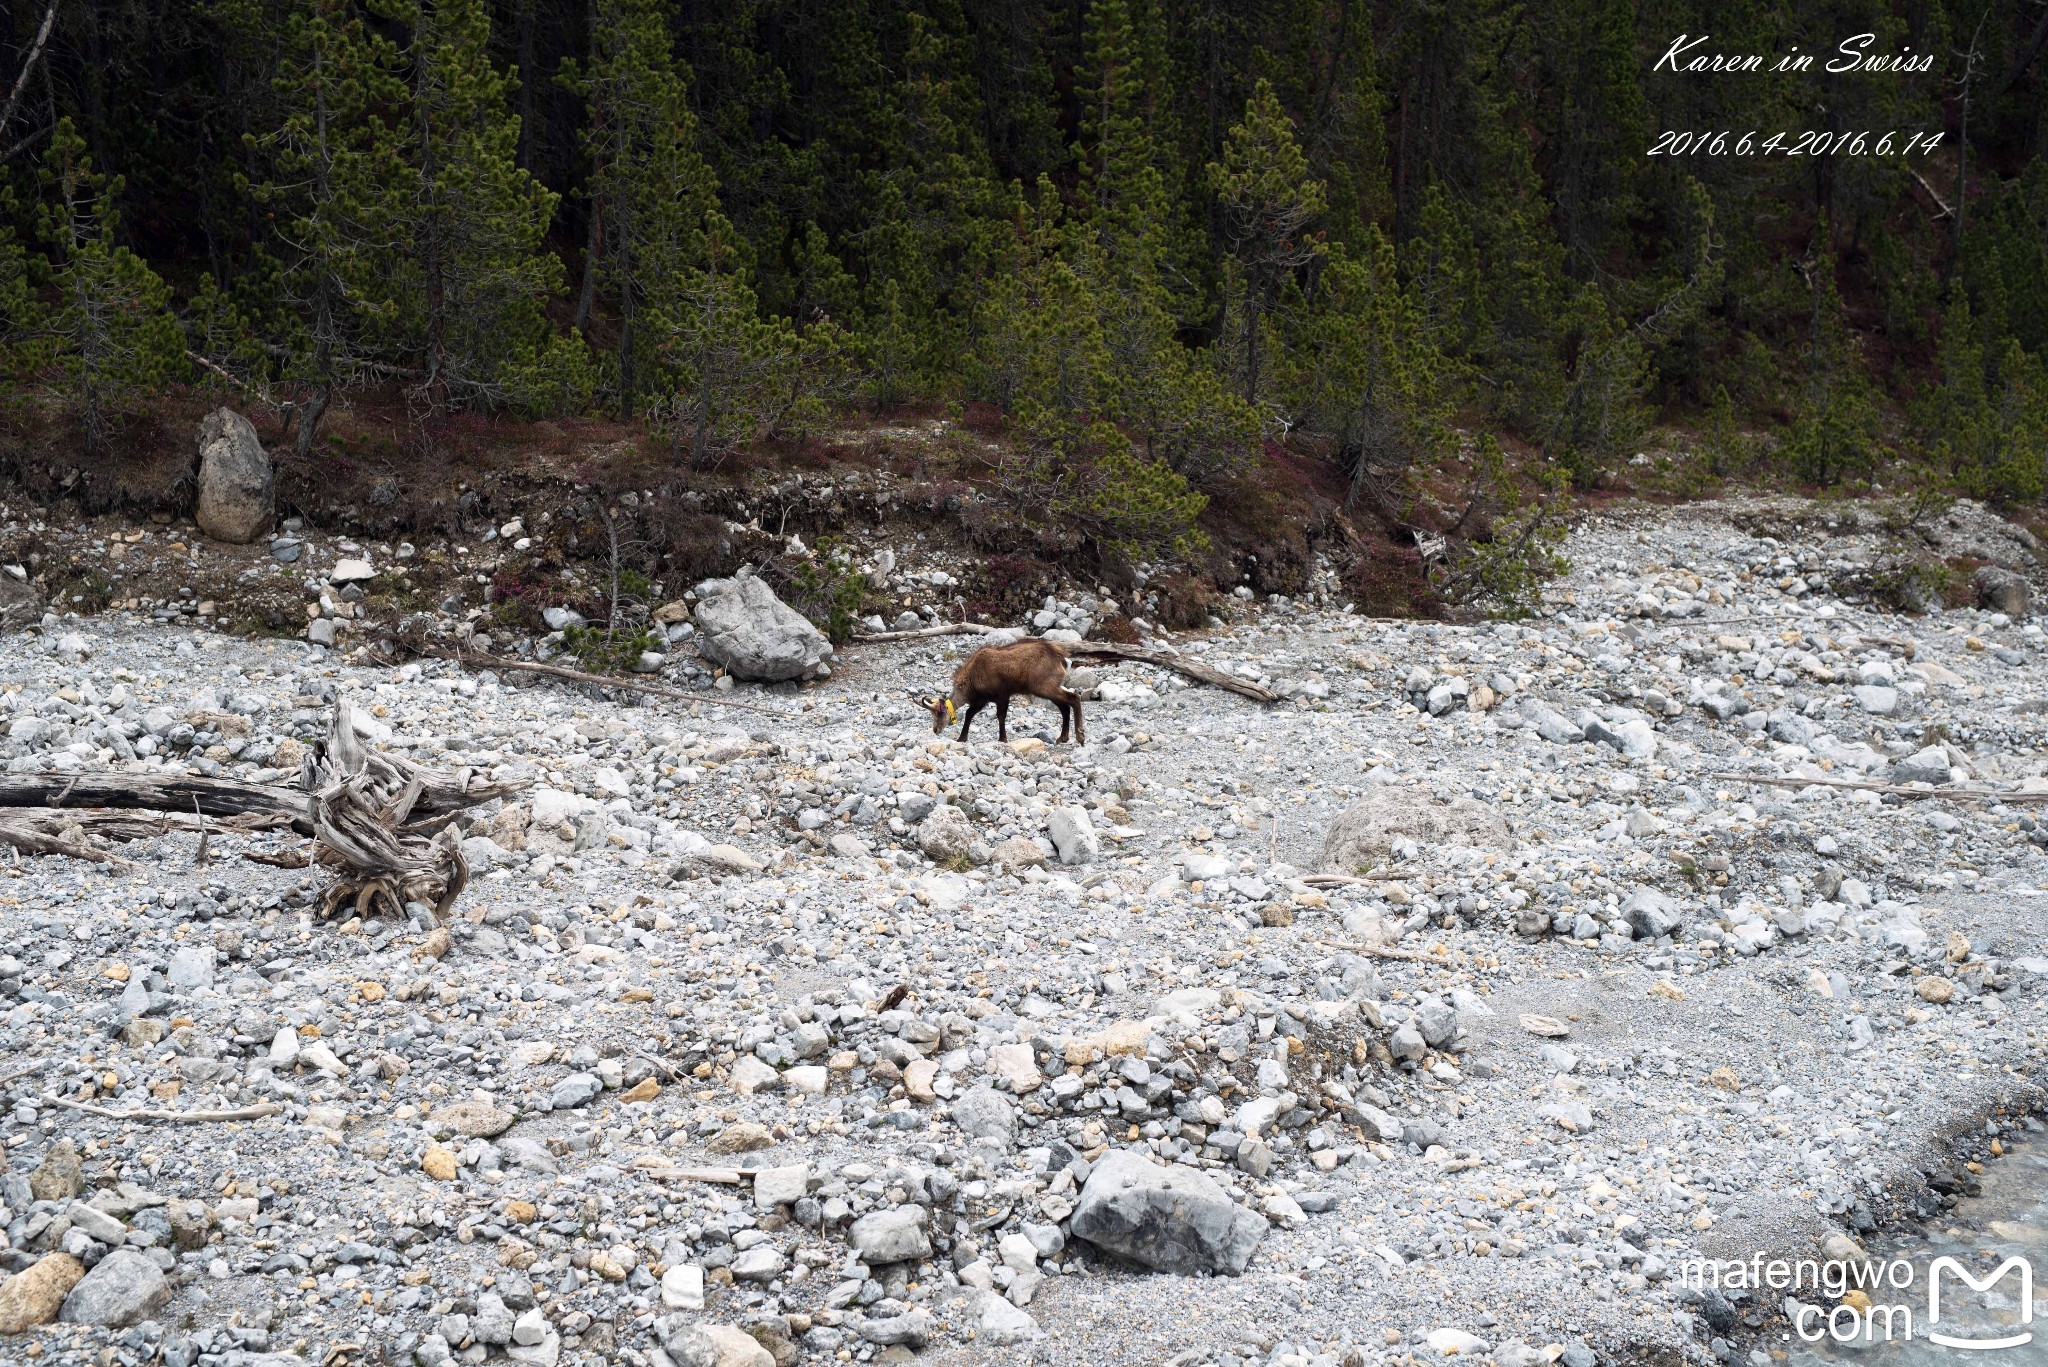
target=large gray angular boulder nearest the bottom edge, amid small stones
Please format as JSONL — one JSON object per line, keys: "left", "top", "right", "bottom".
{"left": 1067, "top": 1150, "right": 1270, "bottom": 1277}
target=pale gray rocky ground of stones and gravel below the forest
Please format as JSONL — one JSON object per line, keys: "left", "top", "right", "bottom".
{"left": 0, "top": 500, "right": 2048, "bottom": 1367}
